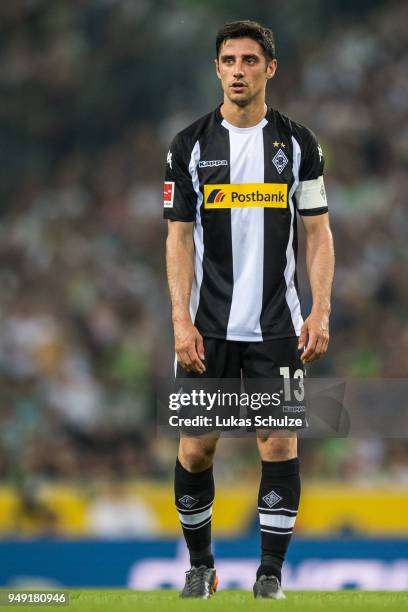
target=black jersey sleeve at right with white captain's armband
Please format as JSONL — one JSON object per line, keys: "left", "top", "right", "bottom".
{"left": 295, "top": 127, "right": 328, "bottom": 215}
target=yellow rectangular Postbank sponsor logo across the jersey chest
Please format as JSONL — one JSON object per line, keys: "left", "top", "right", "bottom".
{"left": 204, "top": 183, "right": 288, "bottom": 210}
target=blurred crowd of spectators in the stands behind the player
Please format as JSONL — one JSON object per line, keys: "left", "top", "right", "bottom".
{"left": 0, "top": 0, "right": 408, "bottom": 516}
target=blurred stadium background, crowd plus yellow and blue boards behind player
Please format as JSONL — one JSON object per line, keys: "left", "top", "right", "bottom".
{"left": 0, "top": 0, "right": 408, "bottom": 588}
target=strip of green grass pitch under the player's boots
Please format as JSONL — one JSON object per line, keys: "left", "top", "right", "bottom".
{"left": 1, "top": 589, "right": 408, "bottom": 612}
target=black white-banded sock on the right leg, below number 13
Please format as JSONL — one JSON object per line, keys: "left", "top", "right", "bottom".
{"left": 256, "top": 457, "right": 300, "bottom": 581}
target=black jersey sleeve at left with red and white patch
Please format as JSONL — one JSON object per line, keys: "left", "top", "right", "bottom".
{"left": 163, "top": 135, "right": 197, "bottom": 221}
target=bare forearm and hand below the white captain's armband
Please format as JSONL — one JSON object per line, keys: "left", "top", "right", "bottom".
{"left": 299, "top": 214, "right": 334, "bottom": 363}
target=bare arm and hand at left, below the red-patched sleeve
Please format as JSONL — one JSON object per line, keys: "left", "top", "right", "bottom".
{"left": 166, "top": 221, "right": 205, "bottom": 374}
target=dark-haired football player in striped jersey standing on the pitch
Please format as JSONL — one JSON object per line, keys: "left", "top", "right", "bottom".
{"left": 164, "top": 21, "right": 334, "bottom": 599}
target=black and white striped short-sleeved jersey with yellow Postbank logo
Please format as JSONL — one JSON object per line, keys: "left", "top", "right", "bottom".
{"left": 164, "top": 109, "right": 327, "bottom": 342}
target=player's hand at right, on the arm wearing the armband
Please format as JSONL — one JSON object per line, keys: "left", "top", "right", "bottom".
{"left": 298, "top": 309, "right": 329, "bottom": 364}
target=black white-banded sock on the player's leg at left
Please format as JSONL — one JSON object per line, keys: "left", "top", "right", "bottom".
{"left": 174, "top": 459, "right": 214, "bottom": 567}
